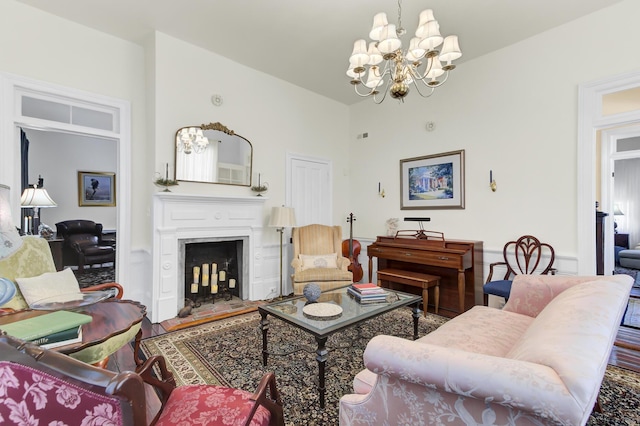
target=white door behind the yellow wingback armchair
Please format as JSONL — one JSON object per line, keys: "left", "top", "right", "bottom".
{"left": 287, "top": 154, "right": 332, "bottom": 226}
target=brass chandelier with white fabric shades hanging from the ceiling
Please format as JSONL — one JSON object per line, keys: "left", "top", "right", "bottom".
{"left": 347, "top": 0, "right": 462, "bottom": 104}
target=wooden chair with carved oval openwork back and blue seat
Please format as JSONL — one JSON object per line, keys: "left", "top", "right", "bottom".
{"left": 482, "top": 235, "right": 556, "bottom": 306}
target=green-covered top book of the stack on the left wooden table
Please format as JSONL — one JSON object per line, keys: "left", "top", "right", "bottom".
{"left": 0, "top": 311, "right": 93, "bottom": 341}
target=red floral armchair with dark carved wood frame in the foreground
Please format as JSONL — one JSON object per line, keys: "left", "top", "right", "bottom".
{"left": 0, "top": 334, "right": 284, "bottom": 426}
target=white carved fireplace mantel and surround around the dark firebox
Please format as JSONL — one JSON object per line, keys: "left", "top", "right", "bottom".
{"left": 151, "top": 192, "right": 268, "bottom": 322}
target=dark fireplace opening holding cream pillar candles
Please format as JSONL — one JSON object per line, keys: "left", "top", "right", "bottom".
{"left": 184, "top": 239, "right": 243, "bottom": 307}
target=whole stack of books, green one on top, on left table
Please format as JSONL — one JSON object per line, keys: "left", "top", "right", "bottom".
{"left": 0, "top": 311, "right": 93, "bottom": 349}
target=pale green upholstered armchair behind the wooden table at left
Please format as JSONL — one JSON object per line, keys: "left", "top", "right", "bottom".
{"left": 0, "top": 236, "right": 131, "bottom": 365}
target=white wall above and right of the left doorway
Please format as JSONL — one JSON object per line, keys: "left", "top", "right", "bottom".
{"left": 0, "top": 0, "right": 146, "bottom": 249}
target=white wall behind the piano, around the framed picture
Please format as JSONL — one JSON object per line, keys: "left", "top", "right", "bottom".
{"left": 349, "top": 0, "right": 640, "bottom": 257}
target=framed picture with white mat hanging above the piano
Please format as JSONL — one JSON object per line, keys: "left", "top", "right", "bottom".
{"left": 400, "top": 149, "right": 464, "bottom": 210}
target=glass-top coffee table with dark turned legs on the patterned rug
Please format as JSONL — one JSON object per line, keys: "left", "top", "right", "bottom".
{"left": 258, "top": 286, "right": 422, "bottom": 408}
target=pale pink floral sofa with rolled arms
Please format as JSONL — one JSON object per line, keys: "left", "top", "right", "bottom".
{"left": 340, "top": 275, "right": 633, "bottom": 425}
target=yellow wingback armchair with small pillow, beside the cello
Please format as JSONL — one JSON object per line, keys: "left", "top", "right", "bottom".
{"left": 291, "top": 224, "right": 353, "bottom": 294}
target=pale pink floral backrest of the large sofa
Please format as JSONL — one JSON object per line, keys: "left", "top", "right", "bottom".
{"left": 506, "top": 277, "right": 628, "bottom": 407}
